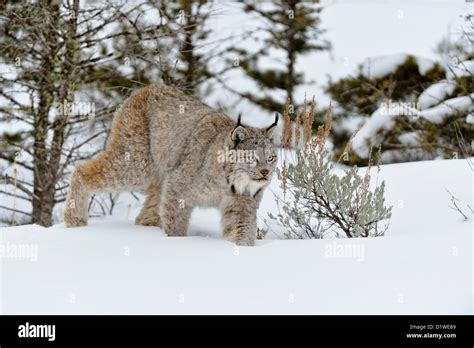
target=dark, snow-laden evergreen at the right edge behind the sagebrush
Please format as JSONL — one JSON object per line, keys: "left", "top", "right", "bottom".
{"left": 326, "top": 55, "right": 474, "bottom": 164}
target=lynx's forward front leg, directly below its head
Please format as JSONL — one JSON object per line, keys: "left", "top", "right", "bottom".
{"left": 221, "top": 196, "right": 258, "bottom": 246}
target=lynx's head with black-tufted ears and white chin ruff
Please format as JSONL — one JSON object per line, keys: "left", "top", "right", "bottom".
{"left": 227, "top": 114, "right": 278, "bottom": 196}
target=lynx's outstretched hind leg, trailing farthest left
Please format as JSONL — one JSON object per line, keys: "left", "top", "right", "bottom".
{"left": 64, "top": 153, "right": 133, "bottom": 227}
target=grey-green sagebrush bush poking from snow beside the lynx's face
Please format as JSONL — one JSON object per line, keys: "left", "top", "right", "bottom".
{"left": 269, "top": 99, "right": 391, "bottom": 239}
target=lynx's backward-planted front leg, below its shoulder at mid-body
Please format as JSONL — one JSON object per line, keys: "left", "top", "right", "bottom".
{"left": 160, "top": 183, "right": 193, "bottom": 237}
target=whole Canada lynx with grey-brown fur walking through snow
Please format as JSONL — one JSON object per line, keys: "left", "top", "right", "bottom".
{"left": 64, "top": 85, "right": 278, "bottom": 245}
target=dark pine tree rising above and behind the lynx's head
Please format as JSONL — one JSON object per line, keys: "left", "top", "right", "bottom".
{"left": 226, "top": 0, "right": 330, "bottom": 118}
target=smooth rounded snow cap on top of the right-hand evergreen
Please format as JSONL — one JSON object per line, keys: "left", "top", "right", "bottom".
{"left": 361, "top": 53, "right": 435, "bottom": 78}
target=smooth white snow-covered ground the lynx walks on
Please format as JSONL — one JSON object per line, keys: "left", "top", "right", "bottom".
{"left": 0, "top": 159, "right": 473, "bottom": 314}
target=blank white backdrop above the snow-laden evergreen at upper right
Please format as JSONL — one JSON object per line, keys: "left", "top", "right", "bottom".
{"left": 308, "top": 0, "right": 468, "bottom": 76}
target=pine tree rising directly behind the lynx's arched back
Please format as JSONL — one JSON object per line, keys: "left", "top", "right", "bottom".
{"left": 92, "top": 0, "right": 218, "bottom": 100}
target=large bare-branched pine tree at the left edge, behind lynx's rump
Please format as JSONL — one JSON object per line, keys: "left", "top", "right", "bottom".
{"left": 0, "top": 0, "right": 169, "bottom": 226}
